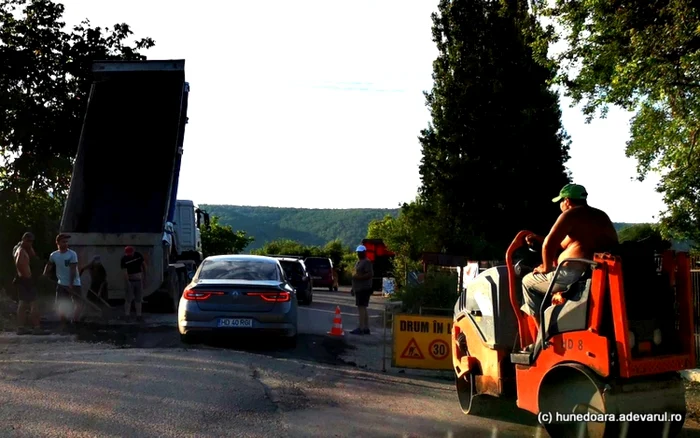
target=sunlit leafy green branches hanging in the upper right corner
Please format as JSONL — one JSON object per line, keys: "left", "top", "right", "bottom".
{"left": 536, "top": 0, "right": 700, "bottom": 241}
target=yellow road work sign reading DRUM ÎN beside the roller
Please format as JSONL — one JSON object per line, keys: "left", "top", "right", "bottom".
{"left": 391, "top": 314, "right": 452, "bottom": 370}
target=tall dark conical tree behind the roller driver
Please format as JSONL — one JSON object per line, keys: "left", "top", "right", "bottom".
{"left": 420, "top": 0, "right": 569, "bottom": 259}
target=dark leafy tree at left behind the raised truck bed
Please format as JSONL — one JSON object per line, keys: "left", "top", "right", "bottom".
{"left": 0, "top": 0, "right": 154, "bottom": 276}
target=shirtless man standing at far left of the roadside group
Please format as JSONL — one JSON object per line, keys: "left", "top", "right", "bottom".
{"left": 12, "top": 233, "right": 46, "bottom": 335}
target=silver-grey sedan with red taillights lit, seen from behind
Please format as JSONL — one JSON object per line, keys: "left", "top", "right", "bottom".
{"left": 177, "top": 255, "right": 298, "bottom": 346}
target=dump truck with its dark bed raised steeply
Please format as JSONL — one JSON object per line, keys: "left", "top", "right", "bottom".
{"left": 60, "top": 60, "right": 201, "bottom": 311}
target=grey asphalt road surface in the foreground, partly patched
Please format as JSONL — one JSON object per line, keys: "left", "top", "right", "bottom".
{"left": 0, "top": 291, "right": 696, "bottom": 437}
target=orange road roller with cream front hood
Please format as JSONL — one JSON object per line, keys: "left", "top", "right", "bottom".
{"left": 452, "top": 231, "right": 695, "bottom": 438}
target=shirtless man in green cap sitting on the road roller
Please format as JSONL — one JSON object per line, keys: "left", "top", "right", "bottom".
{"left": 521, "top": 184, "right": 618, "bottom": 326}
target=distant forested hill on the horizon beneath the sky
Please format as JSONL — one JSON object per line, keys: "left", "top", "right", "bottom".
{"left": 200, "top": 205, "right": 634, "bottom": 252}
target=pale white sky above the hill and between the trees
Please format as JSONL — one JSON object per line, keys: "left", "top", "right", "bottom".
{"left": 57, "top": 0, "right": 663, "bottom": 222}
